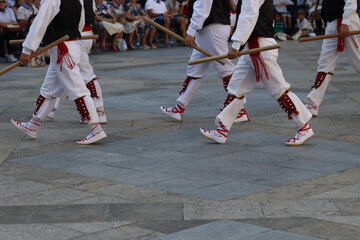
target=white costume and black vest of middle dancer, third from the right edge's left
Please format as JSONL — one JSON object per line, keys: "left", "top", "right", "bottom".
{"left": 160, "top": 0, "right": 248, "bottom": 121}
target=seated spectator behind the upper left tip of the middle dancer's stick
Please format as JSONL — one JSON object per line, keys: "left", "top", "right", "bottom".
{"left": 125, "top": 0, "right": 156, "bottom": 49}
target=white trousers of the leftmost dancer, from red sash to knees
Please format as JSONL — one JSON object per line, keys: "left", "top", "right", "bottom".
{"left": 40, "top": 41, "right": 90, "bottom": 101}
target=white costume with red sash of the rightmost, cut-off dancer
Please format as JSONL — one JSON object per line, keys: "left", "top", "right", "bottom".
{"left": 305, "top": 0, "right": 360, "bottom": 116}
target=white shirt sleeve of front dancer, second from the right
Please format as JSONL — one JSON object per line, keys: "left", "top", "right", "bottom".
{"left": 231, "top": 0, "right": 265, "bottom": 49}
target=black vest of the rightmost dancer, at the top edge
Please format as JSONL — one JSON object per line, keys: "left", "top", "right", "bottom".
{"left": 321, "top": 0, "right": 345, "bottom": 22}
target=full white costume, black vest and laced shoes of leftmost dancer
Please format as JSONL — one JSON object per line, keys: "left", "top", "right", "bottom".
{"left": 11, "top": 0, "right": 106, "bottom": 144}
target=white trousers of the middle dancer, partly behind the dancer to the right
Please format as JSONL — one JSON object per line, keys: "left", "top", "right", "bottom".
{"left": 177, "top": 24, "right": 235, "bottom": 107}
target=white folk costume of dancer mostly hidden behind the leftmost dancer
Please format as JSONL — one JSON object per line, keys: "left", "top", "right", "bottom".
{"left": 48, "top": 0, "right": 107, "bottom": 124}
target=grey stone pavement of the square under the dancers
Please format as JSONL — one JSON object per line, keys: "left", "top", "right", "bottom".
{"left": 0, "top": 39, "right": 360, "bottom": 240}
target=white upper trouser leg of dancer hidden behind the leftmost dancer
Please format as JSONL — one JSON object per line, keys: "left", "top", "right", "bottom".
{"left": 79, "top": 31, "right": 96, "bottom": 83}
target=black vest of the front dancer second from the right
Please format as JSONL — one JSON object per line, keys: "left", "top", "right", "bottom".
{"left": 236, "top": 0, "right": 275, "bottom": 38}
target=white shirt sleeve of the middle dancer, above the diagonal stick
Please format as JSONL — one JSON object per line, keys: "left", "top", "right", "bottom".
{"left": 186, "top": 0, "right": 213, "bottom": 37}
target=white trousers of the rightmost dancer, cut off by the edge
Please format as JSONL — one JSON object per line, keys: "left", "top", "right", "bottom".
{"left": 305, "top": 13, "right": 360, "bottom": 106}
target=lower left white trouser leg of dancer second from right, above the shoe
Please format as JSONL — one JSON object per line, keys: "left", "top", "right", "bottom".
{"left": 215, "top": 98, "right": 244, "bottom": 130}
